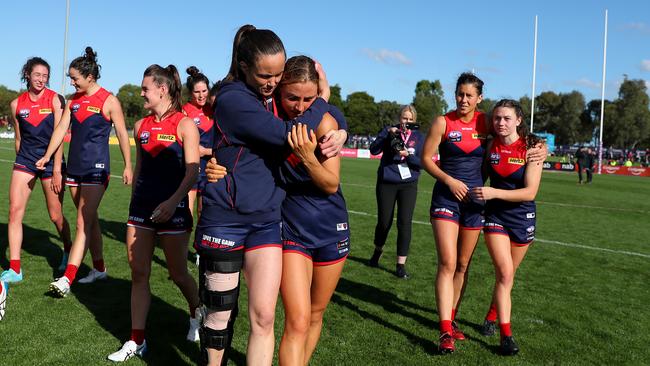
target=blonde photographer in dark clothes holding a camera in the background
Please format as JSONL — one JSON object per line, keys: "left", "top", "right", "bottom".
{"left": 370, "top": 105, "right": 424, "bottom": 279}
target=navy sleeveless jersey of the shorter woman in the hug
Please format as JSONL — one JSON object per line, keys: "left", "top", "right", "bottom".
{"left": 281, "top": 106, "right": 350, "bottom": 248}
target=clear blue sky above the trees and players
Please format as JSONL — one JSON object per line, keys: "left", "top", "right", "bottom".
{"left": 0, "top": 0, "right": 650, "bottom": 105}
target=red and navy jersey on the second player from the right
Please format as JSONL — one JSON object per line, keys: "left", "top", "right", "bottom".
{"left": 438, "top": 111, "right": 487, "bottom": 187}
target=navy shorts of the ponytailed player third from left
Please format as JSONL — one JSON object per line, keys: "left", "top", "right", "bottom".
{"left": 126, "top": 202, "right": 193, "bottom": 235}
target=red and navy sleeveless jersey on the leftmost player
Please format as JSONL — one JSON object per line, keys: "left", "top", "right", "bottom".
{"left": 16, "top": 88, "right": 57, "bottom": 163}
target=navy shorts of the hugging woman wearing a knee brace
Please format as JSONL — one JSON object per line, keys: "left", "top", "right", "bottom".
{"left": 194, "top": 220, "right": 282, "bottom": 252}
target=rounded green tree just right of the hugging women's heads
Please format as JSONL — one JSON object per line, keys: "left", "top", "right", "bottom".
{"left": 344, "top": 92, "right": 381, "bottom": 135}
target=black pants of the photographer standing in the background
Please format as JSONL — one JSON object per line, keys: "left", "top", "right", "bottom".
{"left": 375, "top": 181, "right": 418, "bottom": 256}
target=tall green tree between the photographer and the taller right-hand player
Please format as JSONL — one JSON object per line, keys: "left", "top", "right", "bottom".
{"left": 413, "top": 80, "right": 447, "bottom": 131}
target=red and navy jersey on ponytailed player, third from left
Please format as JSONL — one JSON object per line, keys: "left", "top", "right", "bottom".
{"left": 131, "top": 112, "right": 187, "bottom": 210}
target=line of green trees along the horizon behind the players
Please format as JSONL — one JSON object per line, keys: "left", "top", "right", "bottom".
{"left": 0, "top": 77, "right": 650, "bottom": 148}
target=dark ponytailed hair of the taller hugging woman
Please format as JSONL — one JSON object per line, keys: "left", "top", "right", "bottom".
{"left": 224, "top": 24, "right": 286, "bottom": 81}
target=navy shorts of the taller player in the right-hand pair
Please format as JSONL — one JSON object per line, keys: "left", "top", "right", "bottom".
{"left": 430, "top": 183, "right": 485, "bottom": 230}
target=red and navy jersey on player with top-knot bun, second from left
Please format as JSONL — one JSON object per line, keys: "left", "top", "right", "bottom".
{"left": 68, "top": 88, "right": 113, "bottom": 175}
